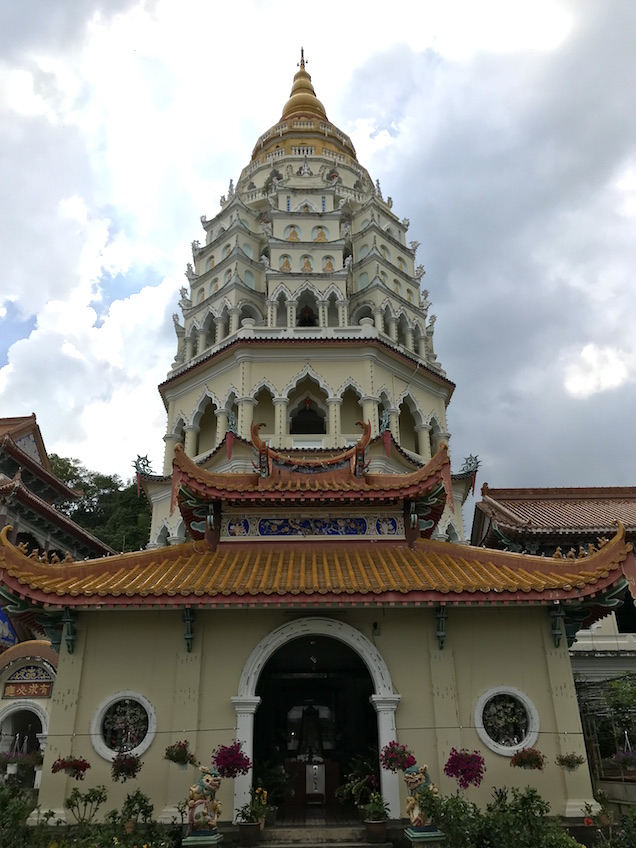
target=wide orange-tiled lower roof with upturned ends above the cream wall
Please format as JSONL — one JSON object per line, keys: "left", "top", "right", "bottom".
{"left": 0, "top": 526, "right": 636, "bottom": 617}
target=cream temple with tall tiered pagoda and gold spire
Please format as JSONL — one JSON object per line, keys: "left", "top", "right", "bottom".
{"left": 0, "top": 56, "right": 635, "bottom": 821}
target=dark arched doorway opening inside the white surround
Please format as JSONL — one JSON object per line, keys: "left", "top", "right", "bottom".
{"left": 254, "top": 633, "right": 378, "bottom": 811}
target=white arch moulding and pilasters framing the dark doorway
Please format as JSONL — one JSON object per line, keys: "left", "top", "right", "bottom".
{"left": 232, "top": 617, "right": 400, "bottom": 818}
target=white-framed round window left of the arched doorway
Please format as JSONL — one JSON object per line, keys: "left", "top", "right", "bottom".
{"left": 91, "top": 691, "right": 157, "bottom": 761}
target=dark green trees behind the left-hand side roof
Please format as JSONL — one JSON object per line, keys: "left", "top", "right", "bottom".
{"left": 49, "top": 453, "right": 151, "bottom": 551}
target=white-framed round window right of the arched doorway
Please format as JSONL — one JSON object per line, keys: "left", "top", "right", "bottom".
{"left": 475, "top": 686, "right": 539, "bottom": 757}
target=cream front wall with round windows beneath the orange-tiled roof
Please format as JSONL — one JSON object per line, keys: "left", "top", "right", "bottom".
{"left": 39, "top": 608, "right": 591, "bottom": 819}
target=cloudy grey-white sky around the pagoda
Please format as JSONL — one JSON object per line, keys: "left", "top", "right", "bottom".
{"left": 0, "top": 0, "right": 636, "bottom": 516}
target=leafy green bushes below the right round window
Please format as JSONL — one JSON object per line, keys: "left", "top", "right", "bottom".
{"left": 417, "top": 787, "right": 578, "bottom": 848}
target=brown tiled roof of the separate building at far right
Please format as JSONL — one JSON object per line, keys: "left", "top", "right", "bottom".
{"left": 473, "top": 484, "right": 636, "bottom": 544}
